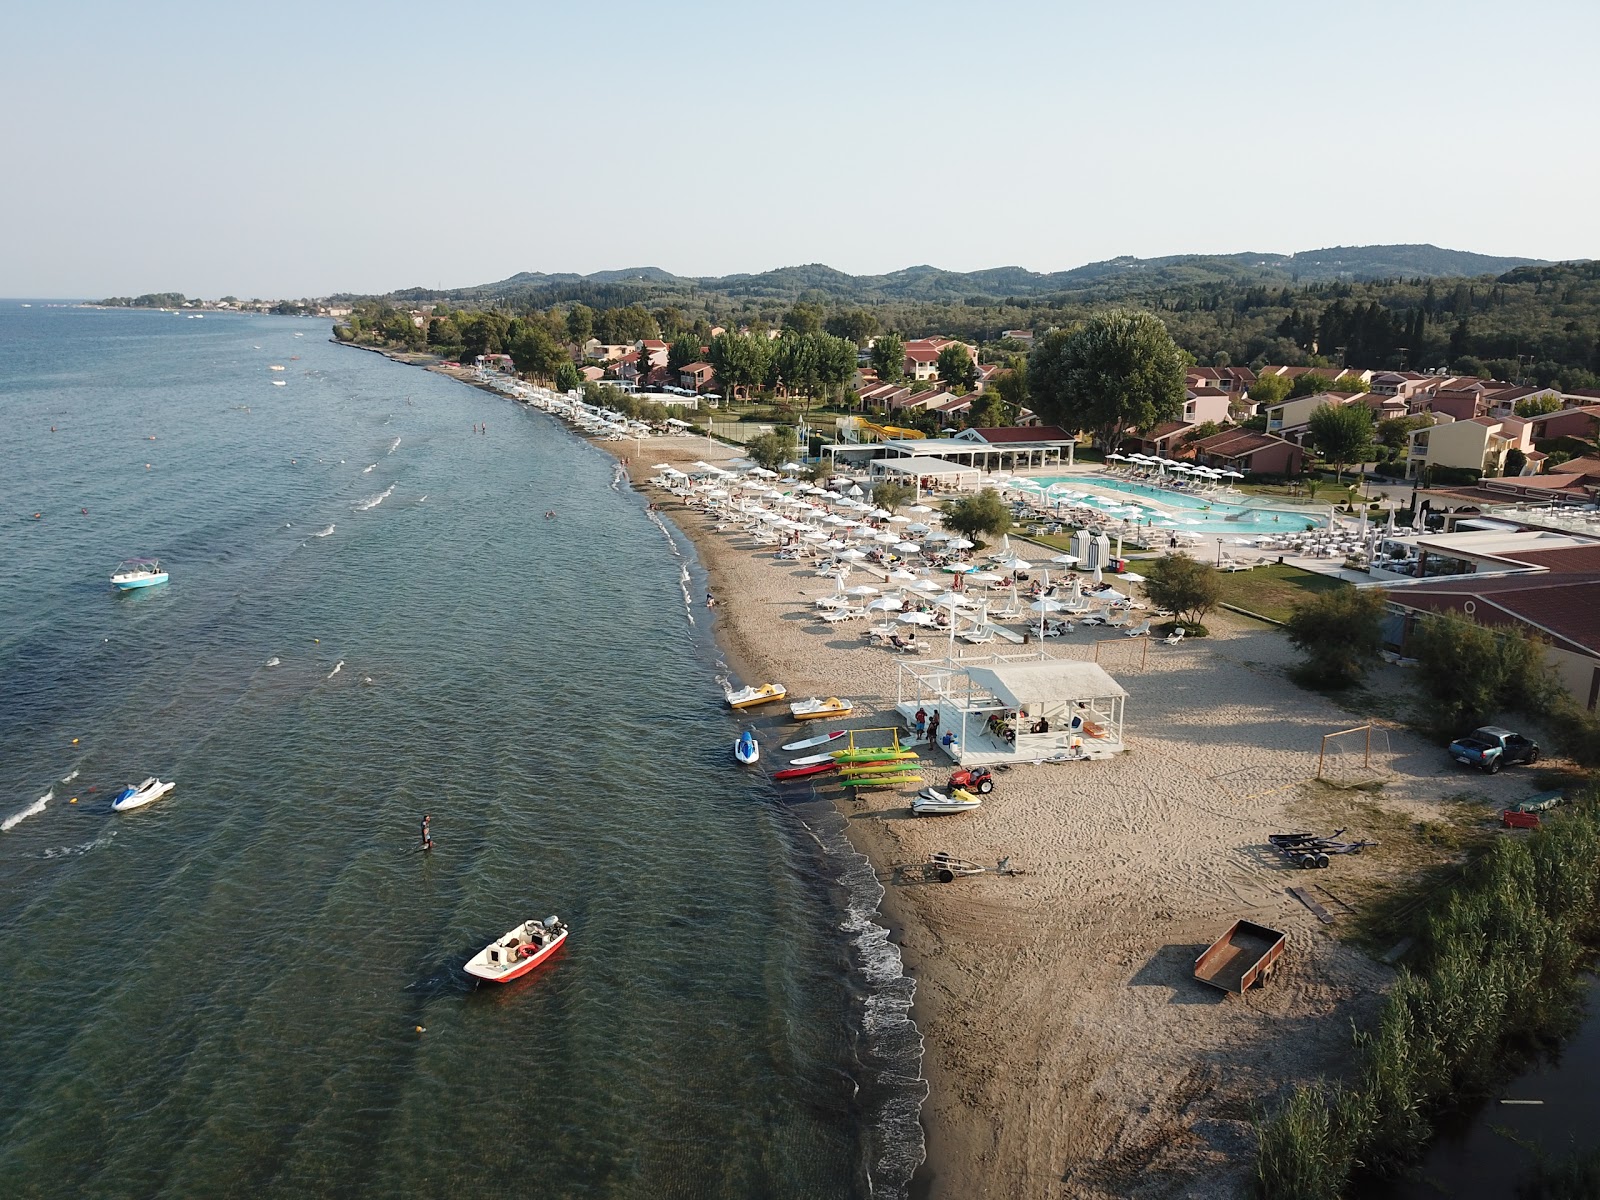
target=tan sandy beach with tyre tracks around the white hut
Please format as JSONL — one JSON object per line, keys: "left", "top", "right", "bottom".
{"left": 448, "top": 380, "right": 1536, "bottom": 1198}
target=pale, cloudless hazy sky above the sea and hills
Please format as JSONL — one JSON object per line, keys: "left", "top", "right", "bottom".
{"left": 0, "top": 0, "right": 1600, "bottom": 298}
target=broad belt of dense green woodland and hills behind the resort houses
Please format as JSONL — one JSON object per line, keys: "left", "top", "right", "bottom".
{"left": 331, "top": 246, "right": 1600, "bottom": 389}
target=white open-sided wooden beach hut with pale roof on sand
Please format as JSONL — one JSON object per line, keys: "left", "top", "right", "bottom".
{"left": 896, "top": 654, "right": 1128, "bottom": 766}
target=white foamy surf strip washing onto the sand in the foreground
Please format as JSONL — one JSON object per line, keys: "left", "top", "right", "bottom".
{"left": 805, "top": 810, "right": 928, "bottom": 1200}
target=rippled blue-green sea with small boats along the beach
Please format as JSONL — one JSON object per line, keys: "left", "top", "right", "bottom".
{"left": 0, "top": 301, "right": 926, "bottom": 1200}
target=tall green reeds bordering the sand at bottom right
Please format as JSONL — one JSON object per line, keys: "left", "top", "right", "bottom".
{"left": 1256, "top": 784, "right": 1600, "bottom": 1200}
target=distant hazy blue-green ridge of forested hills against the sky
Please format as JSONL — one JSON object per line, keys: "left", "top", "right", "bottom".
{"left": 380, "top": 245, "right": 1541, "bottom": 304}
